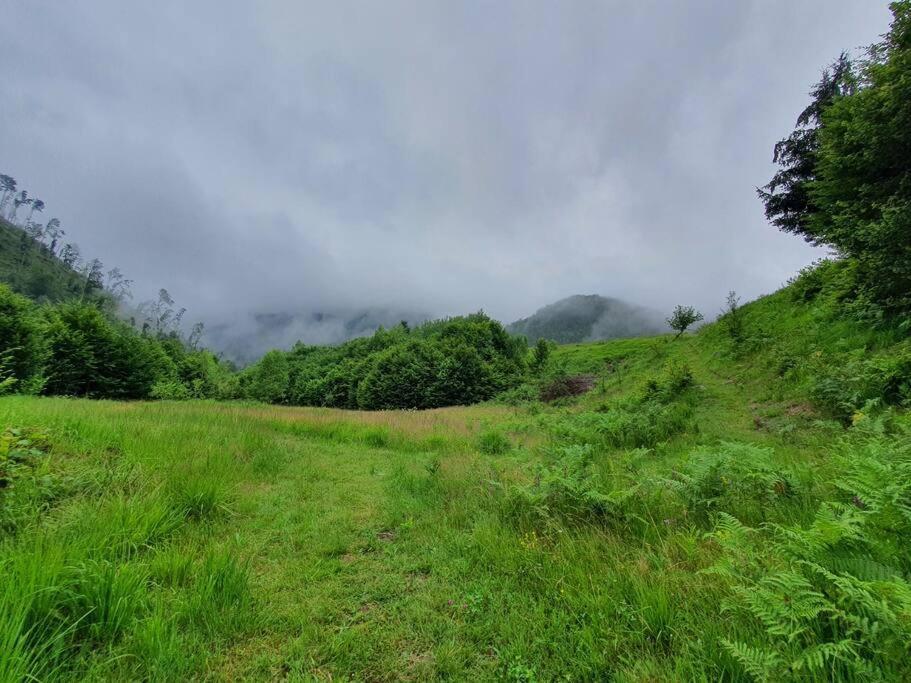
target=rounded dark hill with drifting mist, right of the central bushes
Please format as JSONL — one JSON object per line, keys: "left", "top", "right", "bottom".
{"left": 506, "top": 294, "right": 667, "bottom": 344}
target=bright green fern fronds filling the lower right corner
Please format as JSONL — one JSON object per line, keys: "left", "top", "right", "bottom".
{"left": 705, "top": 438, "right": 911, "bottom": 681}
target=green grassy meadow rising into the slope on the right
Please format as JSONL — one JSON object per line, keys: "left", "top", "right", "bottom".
{"left": 0, "top": 286, "right": 911, "bottom": 681}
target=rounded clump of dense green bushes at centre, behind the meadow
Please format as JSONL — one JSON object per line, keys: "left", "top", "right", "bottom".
{"left": 240, "top": 313, "right": 527, "bottom": 410}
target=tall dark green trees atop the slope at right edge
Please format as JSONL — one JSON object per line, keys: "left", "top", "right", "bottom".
{"left": 759, "top": 0, "right": 911, "bottom": 319}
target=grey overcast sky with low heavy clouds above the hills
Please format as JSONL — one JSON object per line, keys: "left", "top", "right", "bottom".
{"left": 0, "top": 0, "right": 889, "bottom": 323}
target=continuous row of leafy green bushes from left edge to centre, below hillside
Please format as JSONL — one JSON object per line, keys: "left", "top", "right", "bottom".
{"left": 0, "top": 285, "right": 540, "bottom": 410}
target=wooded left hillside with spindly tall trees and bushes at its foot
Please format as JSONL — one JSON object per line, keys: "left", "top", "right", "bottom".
{"left": 0, "top": 174, "right": 238, "bottom": 399}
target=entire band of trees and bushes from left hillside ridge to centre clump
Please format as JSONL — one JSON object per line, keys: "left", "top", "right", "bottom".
{"left": 0, "top": 174, "right": 540, "bottom": 409}
